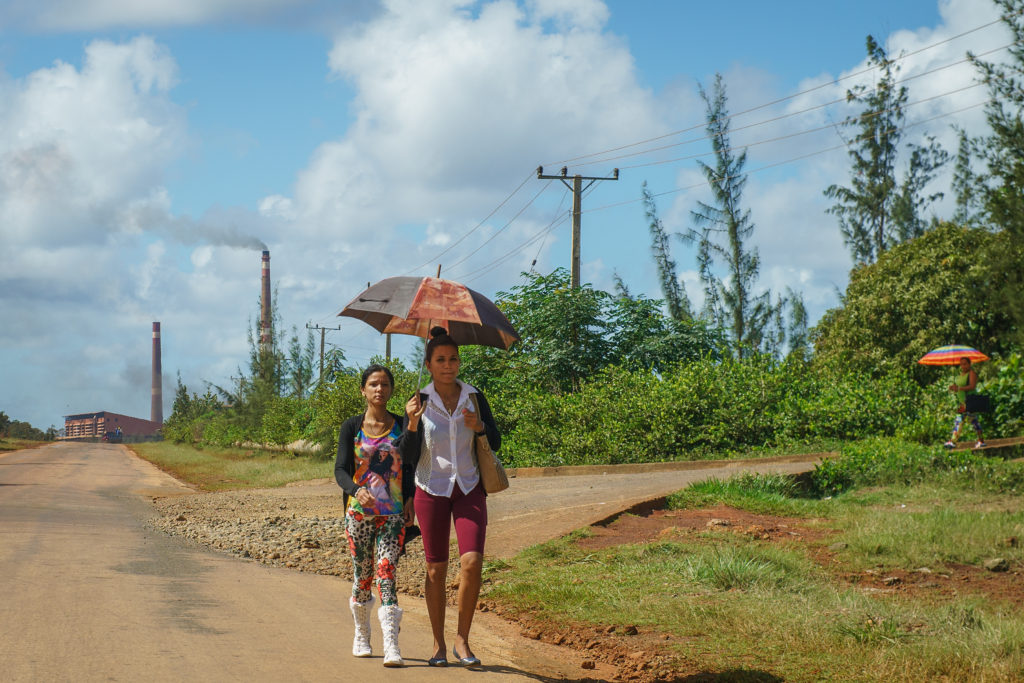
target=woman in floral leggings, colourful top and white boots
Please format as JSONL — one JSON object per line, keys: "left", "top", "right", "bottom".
{"left": 334, "top": 365, "right": 414, "bottom": 667}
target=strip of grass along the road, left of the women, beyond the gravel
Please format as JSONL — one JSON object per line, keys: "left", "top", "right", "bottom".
{"left": 128, "top": 441, "right": 334, "bottom": 490}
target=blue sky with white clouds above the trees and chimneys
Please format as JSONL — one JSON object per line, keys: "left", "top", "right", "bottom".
{"left": 0, "top": 0, "right": 1010, "bottom": 428}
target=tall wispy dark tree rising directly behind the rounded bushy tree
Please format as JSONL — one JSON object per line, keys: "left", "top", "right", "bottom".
{"left": 824, "top": 36, "right": 948, "bottom": 263}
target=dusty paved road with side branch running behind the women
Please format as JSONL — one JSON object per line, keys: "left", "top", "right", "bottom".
{"left": 0, "top": 442, "right": 823, "bottom": 682}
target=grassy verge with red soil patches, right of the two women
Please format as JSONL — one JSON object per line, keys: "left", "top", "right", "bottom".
{"left": 484, "top": 439, "right": 1024, "bottom": 681}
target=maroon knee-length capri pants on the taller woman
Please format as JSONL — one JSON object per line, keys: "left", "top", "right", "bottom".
{"left": 413, "top": 482, "right": 487, "bottom": 564}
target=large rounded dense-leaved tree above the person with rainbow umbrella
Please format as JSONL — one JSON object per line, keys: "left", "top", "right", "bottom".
{"left": 813, "top": 223, "right": 1024, "bottom": 384}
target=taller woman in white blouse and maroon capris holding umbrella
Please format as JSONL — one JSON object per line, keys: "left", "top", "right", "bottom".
{"left": 400, "top": 327, "right": 501, "bottom": 668}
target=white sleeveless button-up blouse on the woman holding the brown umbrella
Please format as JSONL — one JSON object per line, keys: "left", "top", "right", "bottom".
{"left": 416, "top": 380, "right": 480, "bottom": 497}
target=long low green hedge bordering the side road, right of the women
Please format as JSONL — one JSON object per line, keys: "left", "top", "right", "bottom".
{"left": 499, "top": 354, "right": 923, "bottom": 467}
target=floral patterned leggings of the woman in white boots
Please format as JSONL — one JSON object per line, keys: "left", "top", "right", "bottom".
{"left": 345, "top": 509, "right": 406, "bottom": 605}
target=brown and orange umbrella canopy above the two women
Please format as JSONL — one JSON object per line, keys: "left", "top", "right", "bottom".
{"left": 338, "top": 278, "right": 519, "bottom": 348}
